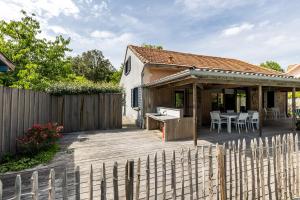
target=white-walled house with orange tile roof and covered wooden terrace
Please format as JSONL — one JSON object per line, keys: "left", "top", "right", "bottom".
{"left": 120, "top": 45, "right": 300, "bottom": 143}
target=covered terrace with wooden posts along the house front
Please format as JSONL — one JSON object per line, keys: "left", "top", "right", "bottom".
{"left": 142, "top": 67, "right": 300, "bottom": 145}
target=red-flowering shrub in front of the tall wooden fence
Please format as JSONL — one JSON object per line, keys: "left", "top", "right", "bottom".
{"left": 17, "top": 123, "right": 63, "bottom": 154}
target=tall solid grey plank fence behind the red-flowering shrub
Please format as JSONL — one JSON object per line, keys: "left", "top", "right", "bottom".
{"left": 0, "top": 86, "right": 122, "bottom": 158}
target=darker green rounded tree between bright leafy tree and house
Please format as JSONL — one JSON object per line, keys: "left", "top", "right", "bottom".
{"left": 72, "top": 49, "right": 116, "bottom": 82}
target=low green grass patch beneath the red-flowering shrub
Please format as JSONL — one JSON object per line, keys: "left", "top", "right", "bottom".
{"left": 0, "top": 144, "right": 59, "bottom": 174}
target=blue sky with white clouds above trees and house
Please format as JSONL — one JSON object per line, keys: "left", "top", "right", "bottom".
{"left": 0, "top": 0, "right": 300, "bottom": 68}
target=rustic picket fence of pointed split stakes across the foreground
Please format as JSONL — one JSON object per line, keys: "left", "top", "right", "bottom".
{"left": 0, "top": 134, "right": 300, "bottom": 200}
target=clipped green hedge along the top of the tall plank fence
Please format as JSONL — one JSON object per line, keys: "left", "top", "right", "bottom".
{"left": 46, "top": 81, "right": 122, "bottom": 96}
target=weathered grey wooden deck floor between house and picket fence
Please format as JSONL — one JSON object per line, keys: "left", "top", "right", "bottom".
{"left": 0, "top": 120, "right": 298, "bottom": 199}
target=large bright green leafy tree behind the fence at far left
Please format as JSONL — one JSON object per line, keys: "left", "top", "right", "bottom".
{"left": 0, "top": 11, "right": 72, "bottom": 89}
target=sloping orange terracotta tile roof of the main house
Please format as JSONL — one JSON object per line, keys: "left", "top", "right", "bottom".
{"left": 128, "top": 45, "right": 283, "bottom": 75}
